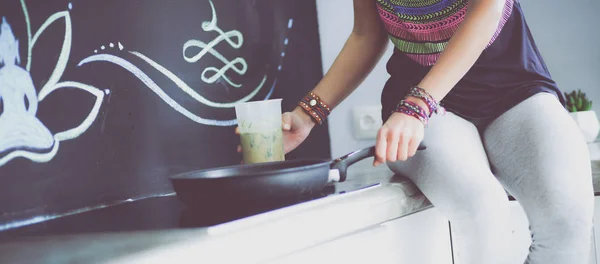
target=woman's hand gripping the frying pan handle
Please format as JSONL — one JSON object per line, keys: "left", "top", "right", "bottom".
{"left": 373, "top": 110, "right": 425, "bottom": 166}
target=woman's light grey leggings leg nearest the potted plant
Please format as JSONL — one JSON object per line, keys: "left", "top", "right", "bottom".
{"left": 483, "top": 93, "right": 593, "bottom": 263}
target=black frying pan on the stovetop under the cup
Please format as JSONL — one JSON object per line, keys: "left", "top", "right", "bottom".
{"left": 169, "top": 144, "right": 426, "bottom": 206}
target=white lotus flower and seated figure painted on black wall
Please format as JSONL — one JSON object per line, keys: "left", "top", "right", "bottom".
{"left": 0, "top": 0, "right": 108, "bottom": 166}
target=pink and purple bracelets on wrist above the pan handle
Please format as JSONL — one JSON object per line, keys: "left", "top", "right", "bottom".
{"left": 392, "top": 86, "right": 445, "bottom": 127}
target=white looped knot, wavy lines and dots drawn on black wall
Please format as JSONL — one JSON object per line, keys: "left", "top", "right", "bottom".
{"left": 78, "top": 0, "right": 292, "bottom": 126}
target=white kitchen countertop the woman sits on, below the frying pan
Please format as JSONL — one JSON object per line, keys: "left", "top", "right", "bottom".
{"left": 0, "top": 142, "right": 600, "bottom": 264}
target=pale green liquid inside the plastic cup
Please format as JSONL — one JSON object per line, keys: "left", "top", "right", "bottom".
{"left": 240, "top": 129, "right": 285, "bottom": 164}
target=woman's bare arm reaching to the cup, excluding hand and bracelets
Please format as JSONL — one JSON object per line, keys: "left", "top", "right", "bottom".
{"left": 294, "top": 0, "right": 389, "bottom": 125}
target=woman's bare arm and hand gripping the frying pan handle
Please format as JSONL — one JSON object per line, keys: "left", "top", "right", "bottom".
{"left": 374, "top": 0, "right": 505, "bottom": 166}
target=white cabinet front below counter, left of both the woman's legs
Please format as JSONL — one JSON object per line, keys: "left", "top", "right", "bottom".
{"left": 267, "top": 208, "right": 453, "bottom": 264}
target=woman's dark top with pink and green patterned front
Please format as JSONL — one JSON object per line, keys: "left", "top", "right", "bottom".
{"left": 375, "top": 0, "right": 564, "bottom": 120}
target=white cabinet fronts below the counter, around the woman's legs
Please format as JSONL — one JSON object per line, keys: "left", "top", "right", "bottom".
{"left": 268, "top": 197, "right": 600, "bottom": 264}
